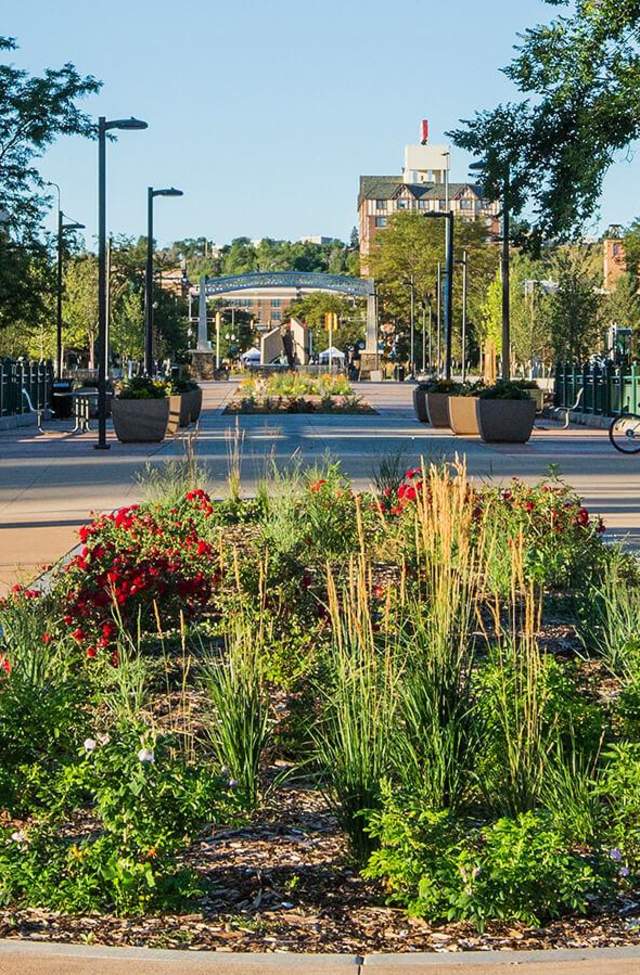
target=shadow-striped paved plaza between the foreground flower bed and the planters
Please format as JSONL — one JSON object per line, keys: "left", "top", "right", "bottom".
{"left": 0, "top": 382, "right": 640, "bottom": 593}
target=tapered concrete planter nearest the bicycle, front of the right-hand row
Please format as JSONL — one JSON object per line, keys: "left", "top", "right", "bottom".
{"left": 476, "top": 380, "right": 536, "bottom": 443}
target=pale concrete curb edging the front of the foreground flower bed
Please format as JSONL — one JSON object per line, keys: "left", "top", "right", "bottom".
{"left": 0, "top": 941, "right": 640, "bottom": 975}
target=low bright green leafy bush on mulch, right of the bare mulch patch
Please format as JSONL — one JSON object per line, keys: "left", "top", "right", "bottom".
{"left": 364, "top": 795, "right": 606, "bottom": 929}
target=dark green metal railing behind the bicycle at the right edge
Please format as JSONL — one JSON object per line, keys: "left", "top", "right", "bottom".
{"left": 554, "top": 362, "right": 640, "bottom": 416}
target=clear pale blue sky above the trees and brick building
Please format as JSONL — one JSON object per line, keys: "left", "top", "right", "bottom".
{"left": 1, "top": 0, "right": 640, "bottom": 248}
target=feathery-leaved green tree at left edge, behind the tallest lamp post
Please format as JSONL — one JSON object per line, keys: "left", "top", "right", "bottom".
{"left": 0, "top": 37, "right": 100, "bottom": 328}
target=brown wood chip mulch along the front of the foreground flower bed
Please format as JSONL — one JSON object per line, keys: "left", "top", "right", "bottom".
{"left": 0, "top": 784, "right": 640, "bottom": 954}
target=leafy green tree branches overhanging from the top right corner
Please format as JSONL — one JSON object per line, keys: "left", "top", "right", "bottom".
{"left": 450, "top": 0, "right": 640, "bottom": 242}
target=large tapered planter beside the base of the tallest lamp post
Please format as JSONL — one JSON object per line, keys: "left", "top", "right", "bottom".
{"left": 112, "top": 376, "right": 181, "bottom": 443}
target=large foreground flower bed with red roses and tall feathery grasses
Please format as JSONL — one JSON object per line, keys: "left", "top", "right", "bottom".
{"left": 0, "top": 465, "right": 640, "bottom": 952}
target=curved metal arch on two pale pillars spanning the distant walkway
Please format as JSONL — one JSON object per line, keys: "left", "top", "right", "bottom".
{"left": 198, "top": 271, "right": 378, "bottom": 353}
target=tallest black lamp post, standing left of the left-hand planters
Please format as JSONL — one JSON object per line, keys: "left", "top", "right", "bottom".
{"left": 94, "top": 115, "right": 148, "bottom": 450}
